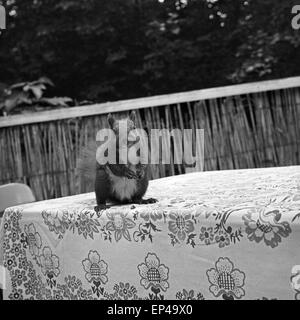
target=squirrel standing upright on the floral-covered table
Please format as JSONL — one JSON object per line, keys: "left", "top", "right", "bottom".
{"left": 79, "top": 112, "right": 157, "bottom": 212}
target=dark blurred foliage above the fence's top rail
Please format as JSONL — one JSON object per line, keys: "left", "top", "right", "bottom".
{"left": 0, "top": 0, "right": 300, "bottom": 102}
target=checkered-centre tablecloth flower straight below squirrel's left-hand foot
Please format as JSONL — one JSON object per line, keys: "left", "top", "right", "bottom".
{"left": 82, "top": 250, "right": 108, "bottom": 284}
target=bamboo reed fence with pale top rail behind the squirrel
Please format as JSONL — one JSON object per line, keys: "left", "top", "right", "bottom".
{"left": 0, "top": 77, "right": 300, "bottom": 200}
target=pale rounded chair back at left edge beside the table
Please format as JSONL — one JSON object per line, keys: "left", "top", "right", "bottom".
{"left": 0, "top": 183, "right": 36, "bottom": 217}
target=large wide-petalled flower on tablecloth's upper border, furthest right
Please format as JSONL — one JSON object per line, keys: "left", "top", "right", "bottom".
{"left": 243, "top": 208, "right": 292, "bottom": 248}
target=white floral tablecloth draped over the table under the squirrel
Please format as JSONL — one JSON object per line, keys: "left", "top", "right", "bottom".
{"left": 0, "top": 167, "right": 300, "bottom": 300}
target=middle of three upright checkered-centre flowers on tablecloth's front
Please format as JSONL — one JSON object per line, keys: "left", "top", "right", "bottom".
{"left": 138, "top": 253, "right": 169, "bottom": 291}
